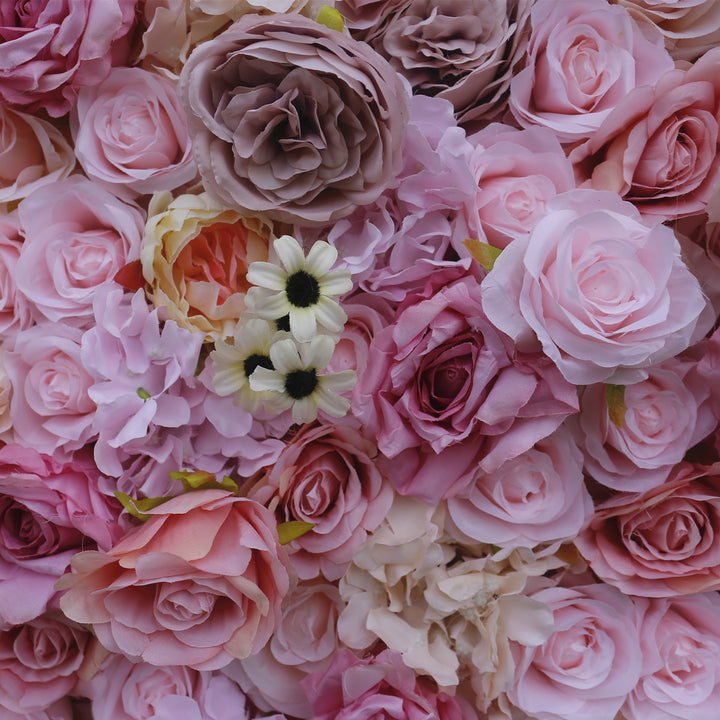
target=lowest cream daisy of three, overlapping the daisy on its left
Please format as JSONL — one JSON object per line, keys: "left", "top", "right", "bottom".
{"left": 250, "top": 335, "right": 357, "bottom": 423}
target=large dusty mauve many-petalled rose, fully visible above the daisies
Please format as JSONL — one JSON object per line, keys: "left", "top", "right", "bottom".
{"left": 180, "top": 14, "right": 409, "bottom": 224}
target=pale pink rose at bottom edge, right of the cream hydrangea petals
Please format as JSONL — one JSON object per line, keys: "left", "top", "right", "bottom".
{"left": 508, "top": 584, "right": 642, "bottom": 720}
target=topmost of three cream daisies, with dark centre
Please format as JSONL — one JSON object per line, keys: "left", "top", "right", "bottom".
{"left": 245, "top": 235, "right": 352, "bottom": 342}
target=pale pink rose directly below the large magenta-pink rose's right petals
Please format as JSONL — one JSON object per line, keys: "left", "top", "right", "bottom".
{"left": 446, "top": 428, "right": 593, "bottom": 547}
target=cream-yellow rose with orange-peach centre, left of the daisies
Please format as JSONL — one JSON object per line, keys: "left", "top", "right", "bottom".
{"left": 140, "top": 193, "right": 272, "bottom": 340}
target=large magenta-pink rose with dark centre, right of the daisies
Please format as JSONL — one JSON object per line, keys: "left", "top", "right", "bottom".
{"left": 353, "top": 272, "right": 577, "bottom": 503}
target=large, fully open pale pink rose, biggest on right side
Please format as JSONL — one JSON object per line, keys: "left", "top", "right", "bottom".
{"left": 482, "top": 190, "right": 706, "bottom": 385}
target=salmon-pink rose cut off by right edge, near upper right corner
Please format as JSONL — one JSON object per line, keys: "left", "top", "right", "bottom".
{"left": 570, "top": 48, "right": 720, "bottom": 220}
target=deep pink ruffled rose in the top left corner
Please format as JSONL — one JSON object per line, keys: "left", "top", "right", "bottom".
{"left": 0, "top": 0, "right": 137, "bottom": 117}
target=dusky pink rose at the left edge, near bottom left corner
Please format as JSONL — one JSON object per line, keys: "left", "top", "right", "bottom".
{"left": 0, "top": 615, "right": 91, "bottom": 717}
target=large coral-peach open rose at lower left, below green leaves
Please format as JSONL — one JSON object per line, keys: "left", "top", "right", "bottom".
{"left": 57, "top": 490, "right": 289, "bottom": 670}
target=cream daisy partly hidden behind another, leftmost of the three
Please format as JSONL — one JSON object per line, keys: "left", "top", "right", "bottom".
{"left": 210, "top": 318, "right": 290, "bottom": 414}
